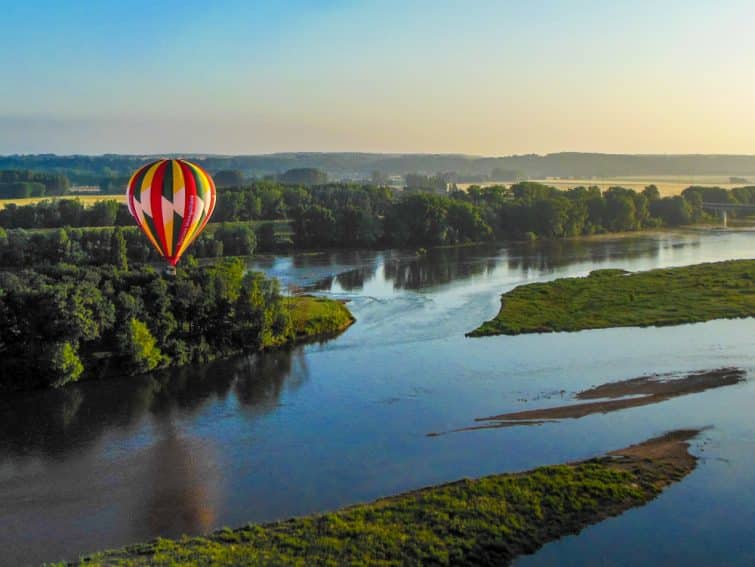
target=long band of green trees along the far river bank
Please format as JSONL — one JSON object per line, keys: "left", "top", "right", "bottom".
{"left": 0, "top": 181, "right": 755, "bottom": 253}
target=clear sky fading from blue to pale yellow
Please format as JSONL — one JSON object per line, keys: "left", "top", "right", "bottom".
{"left": 0, "top": 0, "right": 755, "bottom": 156}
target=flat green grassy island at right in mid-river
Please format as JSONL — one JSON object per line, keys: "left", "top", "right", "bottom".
{"left": 468, "top": 260, "right": 755, "bottom": 337}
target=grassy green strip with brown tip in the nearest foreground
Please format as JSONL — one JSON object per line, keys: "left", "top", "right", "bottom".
{"left": 59, "top": 430, "right": 699, "bottom": 567}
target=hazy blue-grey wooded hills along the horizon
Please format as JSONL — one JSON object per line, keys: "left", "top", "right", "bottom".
{"left": 0, "top": 152, "right": 755, "bottom": 183}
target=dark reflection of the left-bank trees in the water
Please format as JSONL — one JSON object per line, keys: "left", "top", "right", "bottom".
{"left": 0, "top": 348, "right": 307, "bottom": 460}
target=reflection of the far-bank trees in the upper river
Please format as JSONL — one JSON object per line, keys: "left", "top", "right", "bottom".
{"left": 268, "top": 233, "right": 700, "bottom": 293}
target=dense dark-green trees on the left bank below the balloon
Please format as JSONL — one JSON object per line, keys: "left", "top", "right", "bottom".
{"left": 0, "top": 260, "right": 296, "bottom": 391}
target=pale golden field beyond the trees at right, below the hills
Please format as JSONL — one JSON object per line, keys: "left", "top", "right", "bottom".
{"left": 458, "top": 175, "right": 755, "bottom": 197}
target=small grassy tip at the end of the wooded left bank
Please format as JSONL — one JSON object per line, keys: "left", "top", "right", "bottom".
{"left": 288, "top": 295, "right": 355, "bottom": 340}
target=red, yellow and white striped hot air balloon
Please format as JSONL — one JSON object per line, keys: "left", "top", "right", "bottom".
{"left": 126, "top": 159, "right": 216, "bottom": 274}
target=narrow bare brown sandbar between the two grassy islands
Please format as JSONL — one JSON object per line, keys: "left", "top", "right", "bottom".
{"left": 427, "top": 368, "right": 747, "bottom": 437}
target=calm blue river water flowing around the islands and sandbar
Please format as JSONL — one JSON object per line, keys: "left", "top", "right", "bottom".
{"left": 0, "top": 231, "right": 755, "bottom": 565}
